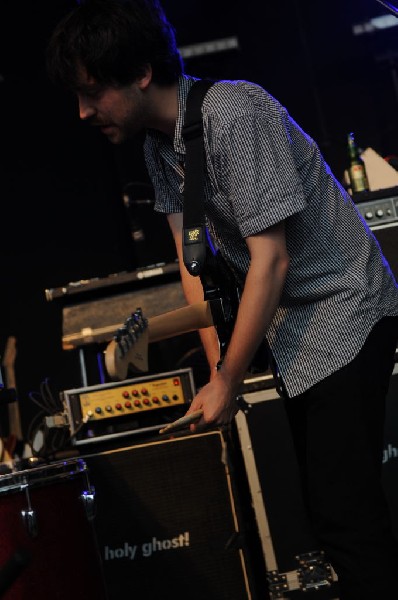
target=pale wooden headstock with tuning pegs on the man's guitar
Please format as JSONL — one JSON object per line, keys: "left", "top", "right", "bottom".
{"left": 105, "top": 308, "right": 148, "bottom": 381}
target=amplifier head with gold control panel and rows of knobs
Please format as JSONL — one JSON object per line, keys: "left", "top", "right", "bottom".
{"left": 60, "top": 367, "right": 195, "bottom": 446}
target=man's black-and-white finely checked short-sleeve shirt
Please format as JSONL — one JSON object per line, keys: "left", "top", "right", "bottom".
{"left": 144, "top": 75, "right": 398, "bottom": 396}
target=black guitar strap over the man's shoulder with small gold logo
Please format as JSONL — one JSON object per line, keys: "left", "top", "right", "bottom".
{"left": 182, "top": 79, "right": 214, "bottom": 276}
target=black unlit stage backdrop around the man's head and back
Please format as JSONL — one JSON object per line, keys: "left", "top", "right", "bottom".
{"left": 0, "top": 0, "right": 398, "bottom": 430}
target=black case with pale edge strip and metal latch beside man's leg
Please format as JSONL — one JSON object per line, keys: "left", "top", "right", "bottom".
{"left": 235, "top": 385, "right": 338, "bottom": 600}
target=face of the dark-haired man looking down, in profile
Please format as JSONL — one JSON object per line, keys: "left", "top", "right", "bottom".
{"left": 76, "top": 68, "right": 146, "bottom": 144}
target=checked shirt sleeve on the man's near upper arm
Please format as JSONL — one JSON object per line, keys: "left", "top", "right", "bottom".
{"left": 211, "top": 92, "right": 306, "bottom": 237}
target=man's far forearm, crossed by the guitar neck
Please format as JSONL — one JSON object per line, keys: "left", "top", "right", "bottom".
{"left": 167, "top": 213, "right": 220, "bottom": 378}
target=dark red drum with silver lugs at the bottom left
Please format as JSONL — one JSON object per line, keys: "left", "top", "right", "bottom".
{"left": 0, "top": 459, "right": 106, "bottom": 600}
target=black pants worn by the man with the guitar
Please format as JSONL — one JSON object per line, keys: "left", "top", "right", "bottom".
{"left": 286, "top": 317, "right": 398, "bottom": 600}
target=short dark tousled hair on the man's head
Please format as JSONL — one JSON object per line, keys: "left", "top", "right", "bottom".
{"left": 47, "top": 0, "right": 183, "bottom": 90}
